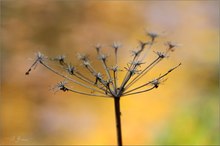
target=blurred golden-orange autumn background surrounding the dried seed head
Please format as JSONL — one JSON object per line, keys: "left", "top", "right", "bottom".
{"left": 0, "top": 0, "right": 219, "bottom": 145}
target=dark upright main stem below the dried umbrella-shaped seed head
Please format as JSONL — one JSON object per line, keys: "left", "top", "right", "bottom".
{"left": 114, "top": 97, "right": 122, "bottom": 146}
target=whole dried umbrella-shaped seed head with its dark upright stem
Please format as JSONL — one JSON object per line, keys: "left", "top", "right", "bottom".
{"left": 25, "top": 32, "right": 181, "bottom": 146}
